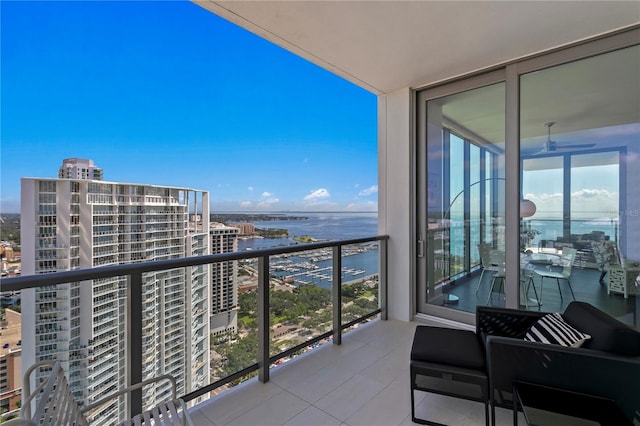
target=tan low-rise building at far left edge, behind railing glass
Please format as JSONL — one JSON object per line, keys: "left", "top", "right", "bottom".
{"left": 0, "top": 309, "right": 22, "bottom": 415}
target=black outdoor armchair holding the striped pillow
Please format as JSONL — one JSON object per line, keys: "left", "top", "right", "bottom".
{"left": 476, "top": 301, "right": 640, "bottom": 426}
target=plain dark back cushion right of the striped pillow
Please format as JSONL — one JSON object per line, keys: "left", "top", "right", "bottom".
{"left": 562, "top": 302, "right": 640, "bottom": 356}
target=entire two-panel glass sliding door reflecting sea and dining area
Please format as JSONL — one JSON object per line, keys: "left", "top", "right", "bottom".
{"left": 415, "top": 31, "right": 640, "bottom": 328}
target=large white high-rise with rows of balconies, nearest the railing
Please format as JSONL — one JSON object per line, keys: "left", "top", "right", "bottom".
{"left": 21, "top": 165, "right": 210, "bottom": 424}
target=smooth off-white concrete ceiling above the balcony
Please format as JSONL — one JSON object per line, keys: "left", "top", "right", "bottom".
{"left": 194, "top": 0, "right": 640, "bottom": 94}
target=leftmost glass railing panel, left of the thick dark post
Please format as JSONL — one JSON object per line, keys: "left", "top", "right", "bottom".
{"left": 5, "top": 276, "right": 127, "bottom": 425}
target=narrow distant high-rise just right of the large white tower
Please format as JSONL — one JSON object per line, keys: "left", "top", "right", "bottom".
{"left": 209, "top": 223, "right": 239, "bottom": 336}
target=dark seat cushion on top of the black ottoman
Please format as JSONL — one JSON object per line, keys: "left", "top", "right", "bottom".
{"left": 411, "top": 325, "right": 485, "bottom": 370}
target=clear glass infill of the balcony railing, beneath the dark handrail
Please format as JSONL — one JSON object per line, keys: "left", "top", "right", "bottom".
{"left": 0, "top": 235, "right": 381, "bottom": 425}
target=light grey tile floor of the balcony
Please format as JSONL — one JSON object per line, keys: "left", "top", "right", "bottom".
{"left": 191, "top": 320, "right": 524, "bottom": 426}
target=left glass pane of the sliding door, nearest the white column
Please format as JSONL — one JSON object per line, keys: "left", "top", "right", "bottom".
{"left": 417, "top": 76, "right": 505, "bottom": 312}
